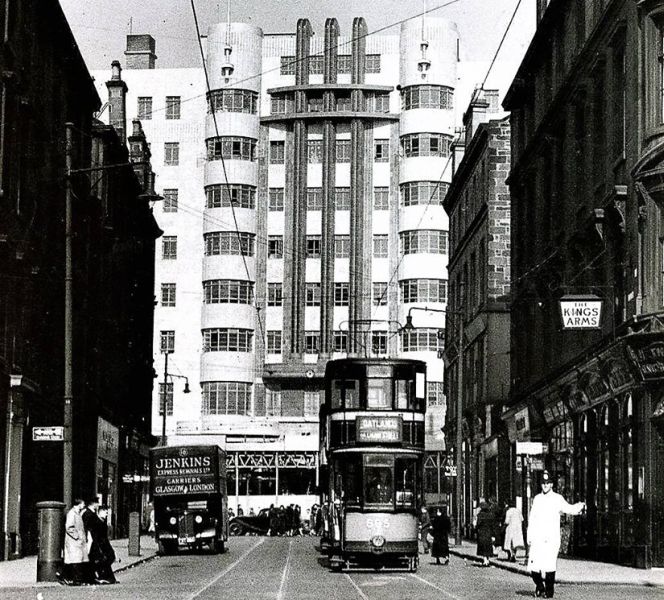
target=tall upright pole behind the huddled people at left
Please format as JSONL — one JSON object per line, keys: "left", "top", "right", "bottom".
{"left": 62, "top": 122, "right": 74, "bottom": 507}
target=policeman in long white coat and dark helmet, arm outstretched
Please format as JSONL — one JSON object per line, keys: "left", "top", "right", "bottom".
{"left": 528, "top": 471, "right": 586, "bottom": 598}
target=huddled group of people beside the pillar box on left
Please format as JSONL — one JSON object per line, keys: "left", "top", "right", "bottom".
{"left": 58, "top": 498, "right": 116, "bottom": 585}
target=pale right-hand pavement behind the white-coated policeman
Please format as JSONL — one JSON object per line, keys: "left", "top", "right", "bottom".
{"left": 450, "top": 540, "right": 664, "bottom": 588}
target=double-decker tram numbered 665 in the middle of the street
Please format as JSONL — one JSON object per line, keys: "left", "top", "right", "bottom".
{"left": 320, "top": 358, "right": 426, "bottom": 571}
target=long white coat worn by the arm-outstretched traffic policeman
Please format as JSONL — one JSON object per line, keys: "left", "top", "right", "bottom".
{"left": 528, "top": 491, "right": 585, "bottom": 573}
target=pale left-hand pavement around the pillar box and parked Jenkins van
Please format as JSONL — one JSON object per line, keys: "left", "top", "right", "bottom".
{"left": 0, "top": 535, "right": 157, "bottom": 588}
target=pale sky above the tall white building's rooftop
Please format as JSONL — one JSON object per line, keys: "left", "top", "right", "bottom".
{"left": 55, "top": 0, "right": 535, "bottom": 101}
